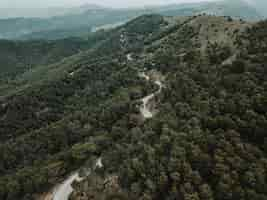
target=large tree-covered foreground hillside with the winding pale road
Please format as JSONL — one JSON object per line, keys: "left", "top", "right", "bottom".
{"left": 0, "top": 15, "right": 267, "bottom": 200}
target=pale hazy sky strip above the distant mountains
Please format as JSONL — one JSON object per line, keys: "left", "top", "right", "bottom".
{"left": 0, "top": 0, "right": 218, "bottom": 8}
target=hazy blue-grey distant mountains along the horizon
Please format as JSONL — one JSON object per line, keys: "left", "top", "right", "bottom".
{"left": 0, "top": 0, "right": 265, "bottom": 40}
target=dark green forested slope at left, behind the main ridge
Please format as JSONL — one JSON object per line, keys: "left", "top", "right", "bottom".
{"left": 0, "top": 31, "right": 110, "bottom": 83}
